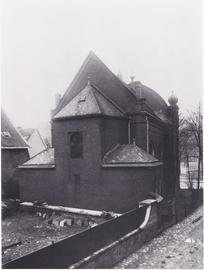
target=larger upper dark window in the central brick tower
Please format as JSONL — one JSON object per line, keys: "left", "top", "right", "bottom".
{"left": 70, "top": 132, "right": 83, "bottom": 158}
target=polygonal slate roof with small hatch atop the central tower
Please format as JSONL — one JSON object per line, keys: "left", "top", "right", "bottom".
{"left": 54, "top": 85, "right": 124, "bottom": 119}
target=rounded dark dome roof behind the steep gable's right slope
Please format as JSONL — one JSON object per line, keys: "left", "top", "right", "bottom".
{"left": 128, "top": 81, "right": 167, "bottom": 113}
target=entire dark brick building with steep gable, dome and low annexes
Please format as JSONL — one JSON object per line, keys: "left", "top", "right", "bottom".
{"left": 19, "top": 52, "right": 179, "bottom": 212}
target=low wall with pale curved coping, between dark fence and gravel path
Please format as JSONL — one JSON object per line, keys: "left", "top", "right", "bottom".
{"left": 69, "top": 200, "right": 158, "bottom": 269}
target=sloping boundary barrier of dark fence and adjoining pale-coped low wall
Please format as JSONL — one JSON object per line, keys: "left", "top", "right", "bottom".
{"left": 3, "top": 201, "right": 158, "bottom": 269}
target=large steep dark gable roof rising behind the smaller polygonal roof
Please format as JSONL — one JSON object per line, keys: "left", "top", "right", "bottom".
{"left": 55, "top": 52, "right": 136, "bottom": 113}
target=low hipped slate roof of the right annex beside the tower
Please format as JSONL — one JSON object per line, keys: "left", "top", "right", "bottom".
{"left": 102, "top": 144, "right": 162, "bottom": 167}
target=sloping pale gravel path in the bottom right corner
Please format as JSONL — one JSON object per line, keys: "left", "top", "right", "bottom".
{"left": 115, "top": 206, "right": 203, "bottom": 269}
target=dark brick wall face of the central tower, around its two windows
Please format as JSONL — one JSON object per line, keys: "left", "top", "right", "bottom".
{"left": 53, "top": 118, "right": 102, "bottom": 209}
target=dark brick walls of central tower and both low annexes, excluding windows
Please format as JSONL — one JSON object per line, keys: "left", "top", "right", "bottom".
{"left": 20, "top": 118, "right": 161, "bottom": 213}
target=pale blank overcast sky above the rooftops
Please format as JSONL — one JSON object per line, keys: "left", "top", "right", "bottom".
{"left": 2, "top": 0, "right": 202, "bottom": 133}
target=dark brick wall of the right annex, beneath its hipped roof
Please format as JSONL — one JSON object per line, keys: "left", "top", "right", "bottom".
{"left": 100, "top": 167, "right": 161, "bottom": 212}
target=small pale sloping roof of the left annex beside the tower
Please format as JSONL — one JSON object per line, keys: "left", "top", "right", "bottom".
{"left": 18, "top": 148, "right": 55, "bottom": 168}
